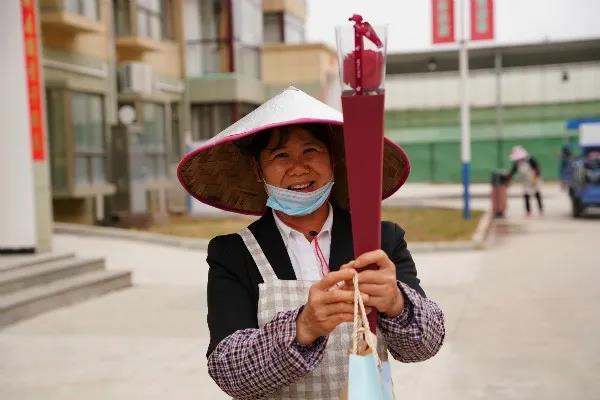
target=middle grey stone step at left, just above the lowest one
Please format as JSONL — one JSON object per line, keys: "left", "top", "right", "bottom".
{"left": 0, "top": 258, "right": 104, "bottom": 295}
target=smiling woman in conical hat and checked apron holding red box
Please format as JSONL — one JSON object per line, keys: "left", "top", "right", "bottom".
{"left": 178, "top": 88, "right": 444, "bottom": 399}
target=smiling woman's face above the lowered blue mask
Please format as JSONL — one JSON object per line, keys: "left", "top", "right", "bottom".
{"left": 259, "top": 126, "right": 333, "bottom": 192}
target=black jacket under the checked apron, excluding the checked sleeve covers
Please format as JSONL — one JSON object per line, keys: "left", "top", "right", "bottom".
{"left": 206, "top": 207, "right": 425, "bottom": 356}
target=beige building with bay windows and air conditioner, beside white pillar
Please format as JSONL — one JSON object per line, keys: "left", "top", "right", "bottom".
{"left": 40, "top": 0, "right": 184, "bottom": 223}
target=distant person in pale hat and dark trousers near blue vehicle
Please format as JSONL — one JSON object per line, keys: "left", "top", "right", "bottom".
{"left": 508, "top": 146, "right": 544, "bottom": 217}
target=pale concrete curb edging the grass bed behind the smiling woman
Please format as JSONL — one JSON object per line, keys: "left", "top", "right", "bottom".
{"left": 53, "top": 210, "right": 494, "bottom": 253}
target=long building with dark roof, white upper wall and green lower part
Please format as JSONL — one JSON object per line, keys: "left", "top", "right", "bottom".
{"left": 386, "top": 39, "right": 600, "bottom": 182}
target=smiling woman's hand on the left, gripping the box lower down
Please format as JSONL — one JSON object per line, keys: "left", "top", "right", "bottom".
{"left": 296, "top": 269, "right": 369, "bottom": 346}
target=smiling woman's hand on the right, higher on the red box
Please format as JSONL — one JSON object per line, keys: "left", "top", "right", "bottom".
{"left": 340, "top": 250, "right": 404, "bottom": 318}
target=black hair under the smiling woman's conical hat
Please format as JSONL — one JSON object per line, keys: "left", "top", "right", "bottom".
{"left": 235, "top": 124, "right": 331, "bottom": 161}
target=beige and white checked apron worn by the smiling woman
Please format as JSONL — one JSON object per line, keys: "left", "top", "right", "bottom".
{"left": 239, "top": 228, "right": 387, "bottom": 400}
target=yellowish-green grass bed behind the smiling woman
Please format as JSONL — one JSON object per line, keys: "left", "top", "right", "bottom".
{"left": 148, "top": 207, "right": 483, "bottom": 242}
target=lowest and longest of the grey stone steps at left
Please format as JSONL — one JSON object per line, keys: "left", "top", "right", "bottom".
{"left": 0, "top": 270, "right": 131, "bottom": 327}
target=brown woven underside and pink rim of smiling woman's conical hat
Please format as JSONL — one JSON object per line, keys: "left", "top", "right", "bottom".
{"left": 177, "top": 118, "right": 410, "bottom": 215}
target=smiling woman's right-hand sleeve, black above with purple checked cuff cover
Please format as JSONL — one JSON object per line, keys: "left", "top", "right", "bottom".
{"left": 378, "top": 224, "right": 445, "bottom": 362}
